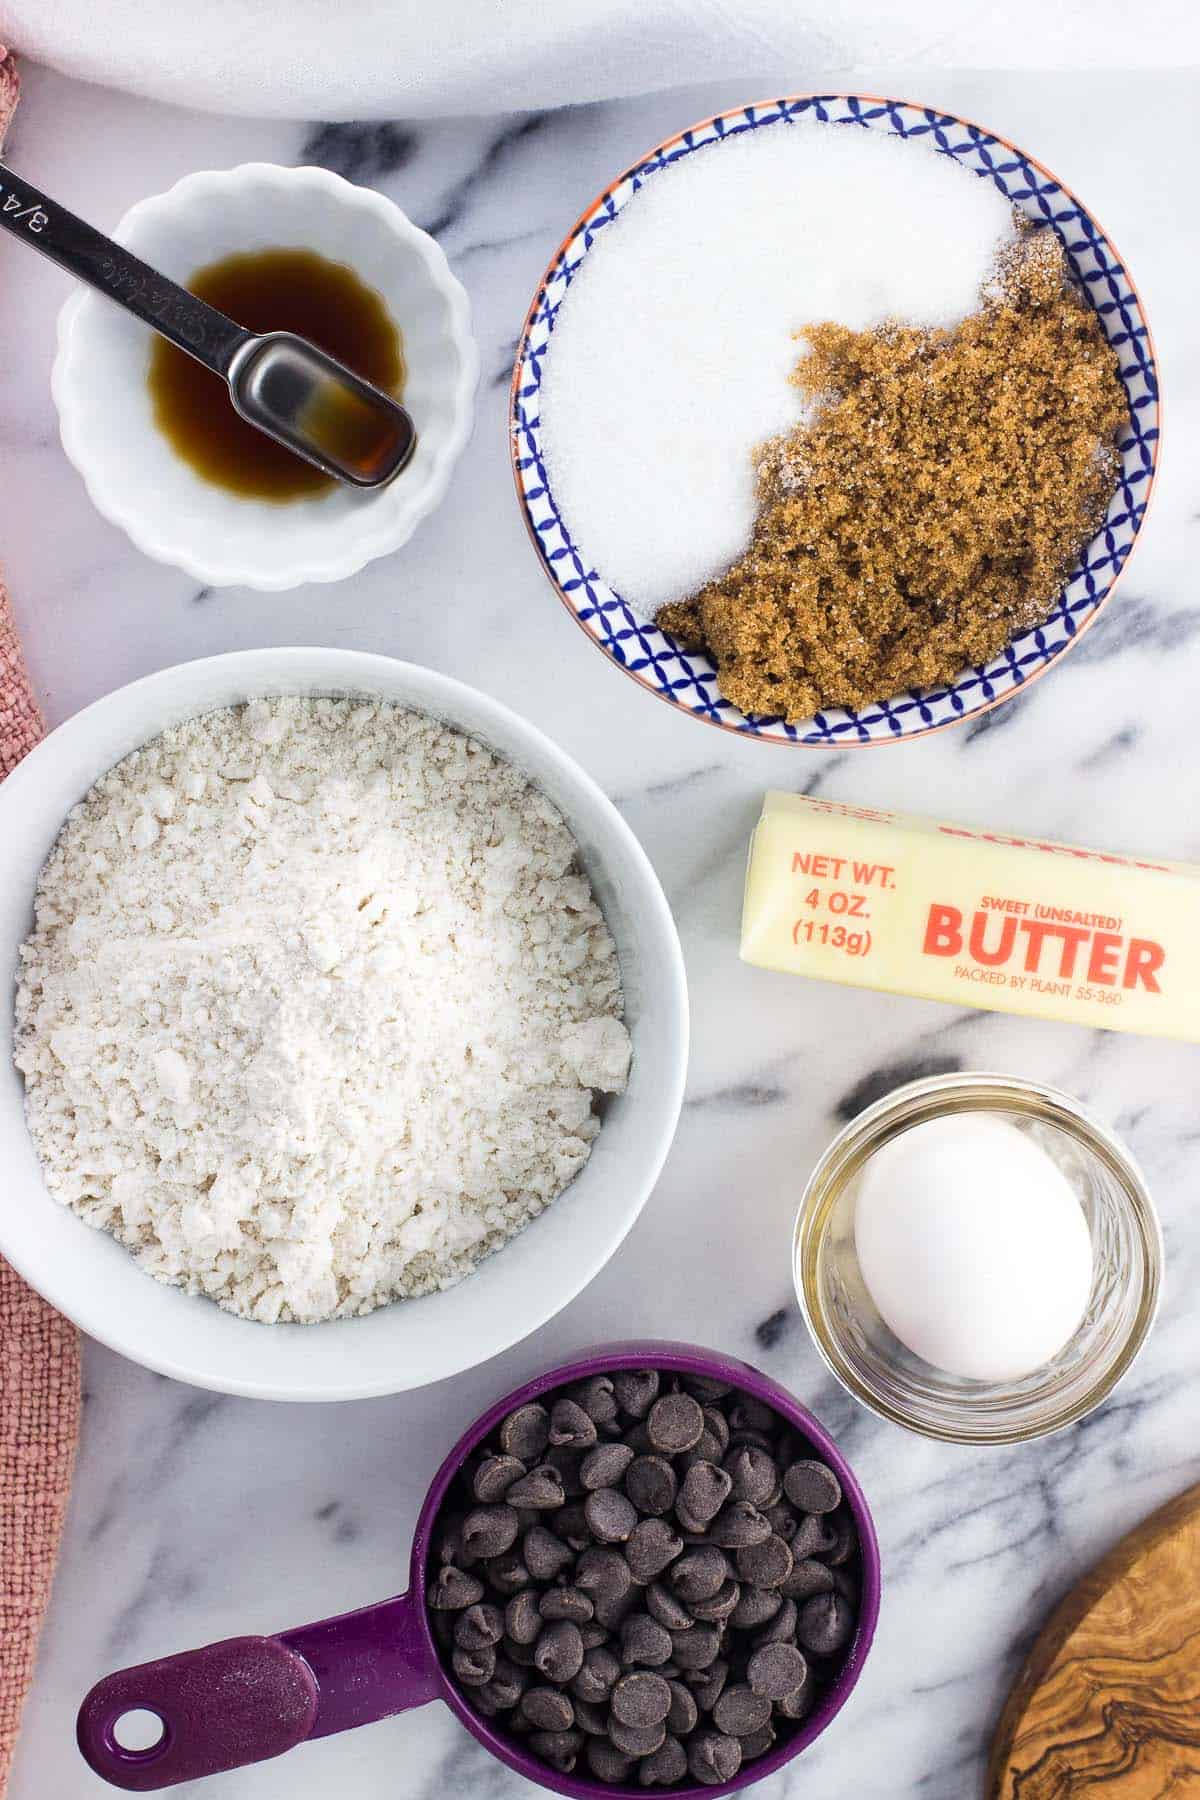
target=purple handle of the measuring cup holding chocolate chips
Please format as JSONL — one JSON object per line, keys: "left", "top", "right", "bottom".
{"left": 76, "top": 1593, "right": 441, "bottom": 1793}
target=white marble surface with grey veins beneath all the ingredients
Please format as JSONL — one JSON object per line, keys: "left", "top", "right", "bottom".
{"left": 0, "top": 56, "right": 1200, "bottom": 1800}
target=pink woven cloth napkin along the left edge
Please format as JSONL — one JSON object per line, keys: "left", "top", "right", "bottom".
{"left": 0, "top": 49, "right": 79, "bottom": 1796}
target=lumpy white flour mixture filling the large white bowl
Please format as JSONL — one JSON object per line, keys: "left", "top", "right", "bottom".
{"left": 16, "top": 700, "right": 630, "bottom": 1321}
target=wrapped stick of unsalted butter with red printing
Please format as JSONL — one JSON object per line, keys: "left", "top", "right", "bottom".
{"left": 741, "top": 794, "right": 1200, "bottom": 1042}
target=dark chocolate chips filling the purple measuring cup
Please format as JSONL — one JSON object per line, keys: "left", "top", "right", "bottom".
{"left": 428, "top": 1370, "right": 858, "bottom": 1787}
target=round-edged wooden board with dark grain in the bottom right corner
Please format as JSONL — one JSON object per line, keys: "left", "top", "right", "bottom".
{"left": 986, "top": 1487, "right": 1200, "bottom": 1800}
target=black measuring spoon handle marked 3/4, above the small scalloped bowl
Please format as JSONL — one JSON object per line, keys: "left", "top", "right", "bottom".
{"left": 0, "top": 162, "right": 254, "bottom": 378}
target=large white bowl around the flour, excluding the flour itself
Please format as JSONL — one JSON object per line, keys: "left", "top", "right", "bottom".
{"left": 0, "top": 650, "right": 687, "bottom": 1400}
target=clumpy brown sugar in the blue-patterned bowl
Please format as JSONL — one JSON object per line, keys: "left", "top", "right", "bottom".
{"left": 657, "top": 229, "right": 1128, "bottom": 720}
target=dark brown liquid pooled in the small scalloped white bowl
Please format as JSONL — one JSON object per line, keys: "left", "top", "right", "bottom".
{"left": 149, "top": 250, "right": 405, "bottom": 500}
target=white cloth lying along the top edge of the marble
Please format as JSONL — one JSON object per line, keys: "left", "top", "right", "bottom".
{"left": 0, "top": 0, "right": 1200, "bottom": 119}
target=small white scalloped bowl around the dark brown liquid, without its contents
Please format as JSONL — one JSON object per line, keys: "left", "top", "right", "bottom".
{"left": 52, "top": 162, "right": 479, "bottom": 589}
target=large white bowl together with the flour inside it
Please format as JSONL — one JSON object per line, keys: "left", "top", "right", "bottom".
{"left": 0, "top": 650, "right": 687, "bottom": 1400}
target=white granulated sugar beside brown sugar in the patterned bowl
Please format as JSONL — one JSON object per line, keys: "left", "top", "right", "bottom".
{"left": 540, "top": 122, "right": 1013, "bottom": 616}
